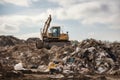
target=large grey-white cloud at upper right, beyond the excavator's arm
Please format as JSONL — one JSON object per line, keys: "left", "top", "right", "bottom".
{"left": 50, "top": 0, "right": 120, "bottom": 29}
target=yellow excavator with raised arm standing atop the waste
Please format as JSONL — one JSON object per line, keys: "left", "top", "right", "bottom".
{"left": 36, "top": 15, "right": 70, "bottom": 49}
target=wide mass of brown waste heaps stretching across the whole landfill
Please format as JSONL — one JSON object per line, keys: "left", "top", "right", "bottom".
{"left": 0, "top": 36, "right": 120, "bottom": 79}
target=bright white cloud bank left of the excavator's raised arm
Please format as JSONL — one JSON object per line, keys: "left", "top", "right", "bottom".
{"left": 0, "top": 13, "right": 51, "bottom": 33}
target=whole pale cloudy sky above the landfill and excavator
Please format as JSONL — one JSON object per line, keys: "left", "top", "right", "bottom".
{"left": 0, "top": 0, "right": 120, "bottom": 41}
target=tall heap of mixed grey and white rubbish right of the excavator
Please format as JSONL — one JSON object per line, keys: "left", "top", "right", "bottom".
{"left": 55, "top": 39, "right": 120, "bottom": 74}
